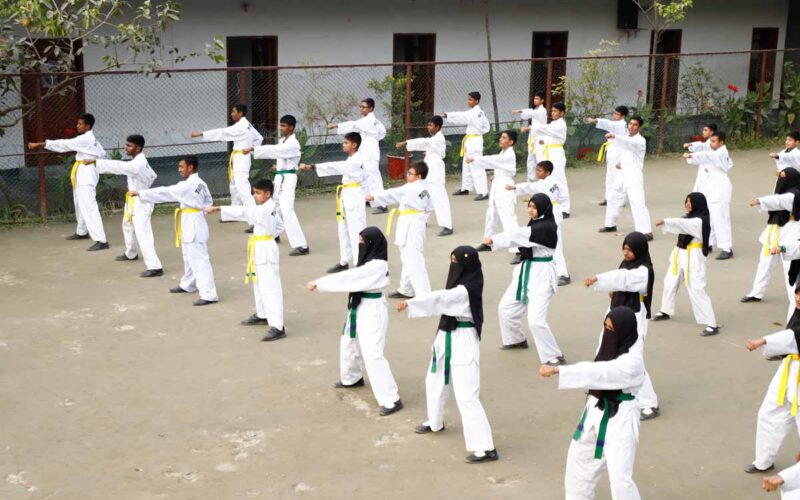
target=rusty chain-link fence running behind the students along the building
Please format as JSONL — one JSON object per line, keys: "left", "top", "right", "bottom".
{"left": 0, "top": 50, "right": 800, "bottom": 221}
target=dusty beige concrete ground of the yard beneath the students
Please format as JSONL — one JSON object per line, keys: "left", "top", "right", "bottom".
{"left": 0, "top": 146, "right": 800, "bottom": 500}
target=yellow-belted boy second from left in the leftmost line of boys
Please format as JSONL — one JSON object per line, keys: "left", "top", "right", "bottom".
{"left": 85, "top": 134, "right": 164, "bottom": 278}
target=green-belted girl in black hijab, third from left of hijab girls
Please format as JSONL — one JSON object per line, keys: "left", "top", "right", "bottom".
{"left": 483, "top": 193, "right": 565, "bottom": 366}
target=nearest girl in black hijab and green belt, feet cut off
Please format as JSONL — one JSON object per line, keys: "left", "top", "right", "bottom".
{"left": 539, "top": 306, "right": 644, "bottom": 500}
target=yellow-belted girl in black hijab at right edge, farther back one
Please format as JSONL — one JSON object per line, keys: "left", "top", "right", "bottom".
{"left": 740, "top": 167, "right": 800, "bottom": 310}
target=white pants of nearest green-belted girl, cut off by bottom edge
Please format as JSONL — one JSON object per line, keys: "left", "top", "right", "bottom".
{"left": 564, "top": 401, "right": 641, "bottom": 500}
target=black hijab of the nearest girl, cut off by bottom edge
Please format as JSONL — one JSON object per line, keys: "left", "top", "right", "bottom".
{"left": 589, "top": 306, "right": 639, "bottom": 417}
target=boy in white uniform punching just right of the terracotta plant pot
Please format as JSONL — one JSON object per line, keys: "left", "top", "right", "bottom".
{"left": 397, "top": 116, "right": 453, "bottom": 236}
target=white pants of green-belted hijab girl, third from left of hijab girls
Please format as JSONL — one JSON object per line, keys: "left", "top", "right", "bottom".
{"left": 497, "top": 261, "right": 561, "bottom": 363}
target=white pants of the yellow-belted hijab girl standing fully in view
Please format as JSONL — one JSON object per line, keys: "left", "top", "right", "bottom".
{"left": 661, "top": 247, "right": 718, "bottom": 327}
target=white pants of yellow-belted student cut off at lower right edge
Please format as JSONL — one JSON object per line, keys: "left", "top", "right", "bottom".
{"left": 753, "top": 362, "right": 800, "bottom": 469}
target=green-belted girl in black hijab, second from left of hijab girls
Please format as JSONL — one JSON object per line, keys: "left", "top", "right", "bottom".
{"left": 397, "top": 246, "right": 497, "bottom": 463}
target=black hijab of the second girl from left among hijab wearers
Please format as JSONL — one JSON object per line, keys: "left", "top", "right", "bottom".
{"left": 439, "top": 246, "right": 483, "bottom": 339}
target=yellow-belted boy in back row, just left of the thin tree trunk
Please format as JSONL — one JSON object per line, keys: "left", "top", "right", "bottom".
{"left": 439, "top": 92, "right": 491, "bottom": 201}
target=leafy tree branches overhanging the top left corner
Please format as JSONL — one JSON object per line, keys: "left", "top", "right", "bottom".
{"left": 0, "top": 0, "right": 224, "bottom": 136}
